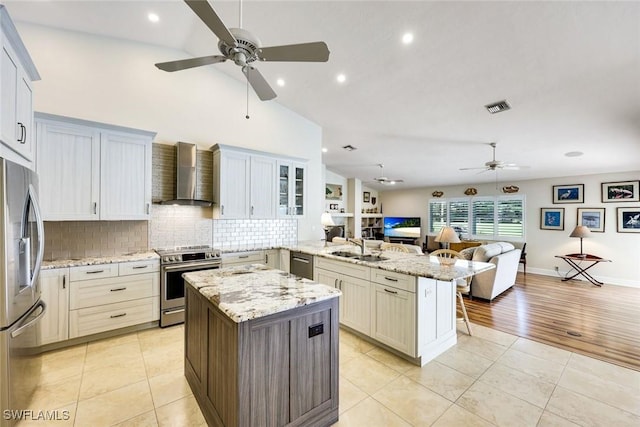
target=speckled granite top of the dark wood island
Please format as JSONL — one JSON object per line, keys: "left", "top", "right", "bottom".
{"left": 183, "top": 264, "right": 341, "bottom": 323}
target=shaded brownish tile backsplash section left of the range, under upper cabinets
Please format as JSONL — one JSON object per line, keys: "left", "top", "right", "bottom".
{"left": 44, "top": 221, "right": 149, "bottom": 261}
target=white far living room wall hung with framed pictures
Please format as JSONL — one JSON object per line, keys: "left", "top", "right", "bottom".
{"left": 380, "top": 171, "right": 640, "bottom": 288}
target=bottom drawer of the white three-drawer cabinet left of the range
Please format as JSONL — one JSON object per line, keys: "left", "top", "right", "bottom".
{"left": 69, "top": 298, "right": 156, "bottom": 338}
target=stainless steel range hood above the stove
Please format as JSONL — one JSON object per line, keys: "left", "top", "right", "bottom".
{"left": 162, "top": 142, "right": 213, "bottom": 206}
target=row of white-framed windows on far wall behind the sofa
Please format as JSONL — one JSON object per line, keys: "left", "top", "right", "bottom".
{"left": 429, "top": 196, "right": 525, "bottom": 240}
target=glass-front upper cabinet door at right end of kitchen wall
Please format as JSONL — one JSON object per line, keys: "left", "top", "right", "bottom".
{"left": 278, "top": 161, "right": 306, "bottom": 217}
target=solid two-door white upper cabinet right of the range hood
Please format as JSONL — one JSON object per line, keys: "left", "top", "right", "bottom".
{"left": 212, "top": 144, "right": 302, "bottom": 219}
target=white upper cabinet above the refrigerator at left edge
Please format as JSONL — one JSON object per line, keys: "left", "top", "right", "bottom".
{"left": 0, "top": 5, "right": 40, "bottom": 161}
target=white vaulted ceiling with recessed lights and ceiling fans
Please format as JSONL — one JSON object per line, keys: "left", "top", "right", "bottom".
{"left": 4, "top": 0, "right": 640, "bottom": 189}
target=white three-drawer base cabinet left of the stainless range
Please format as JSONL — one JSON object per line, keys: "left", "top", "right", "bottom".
{"left": 69, "top": 260, "right": 160, "bottom": 338}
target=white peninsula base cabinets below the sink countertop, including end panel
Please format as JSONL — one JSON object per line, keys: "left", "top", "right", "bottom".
{"left": 314, "top": 257, "right": 456, "bottom": 365}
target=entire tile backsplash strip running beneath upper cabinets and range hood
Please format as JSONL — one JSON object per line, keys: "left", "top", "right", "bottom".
{"left": 45, "top": 204, "right": 298, "bottom": 261}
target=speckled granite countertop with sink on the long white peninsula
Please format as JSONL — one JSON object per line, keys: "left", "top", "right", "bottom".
{"left": 287, "top": 242, "right": 496, "bottom": 281}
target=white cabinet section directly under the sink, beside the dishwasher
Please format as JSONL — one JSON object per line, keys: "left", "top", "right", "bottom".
{"left": 314, "top": 257, "right": 371, "bottom": 335}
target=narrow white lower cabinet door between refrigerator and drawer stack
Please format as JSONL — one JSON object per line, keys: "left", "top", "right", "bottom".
{"left": 36, "top": 268, "right": 69, "bottom": 345}
